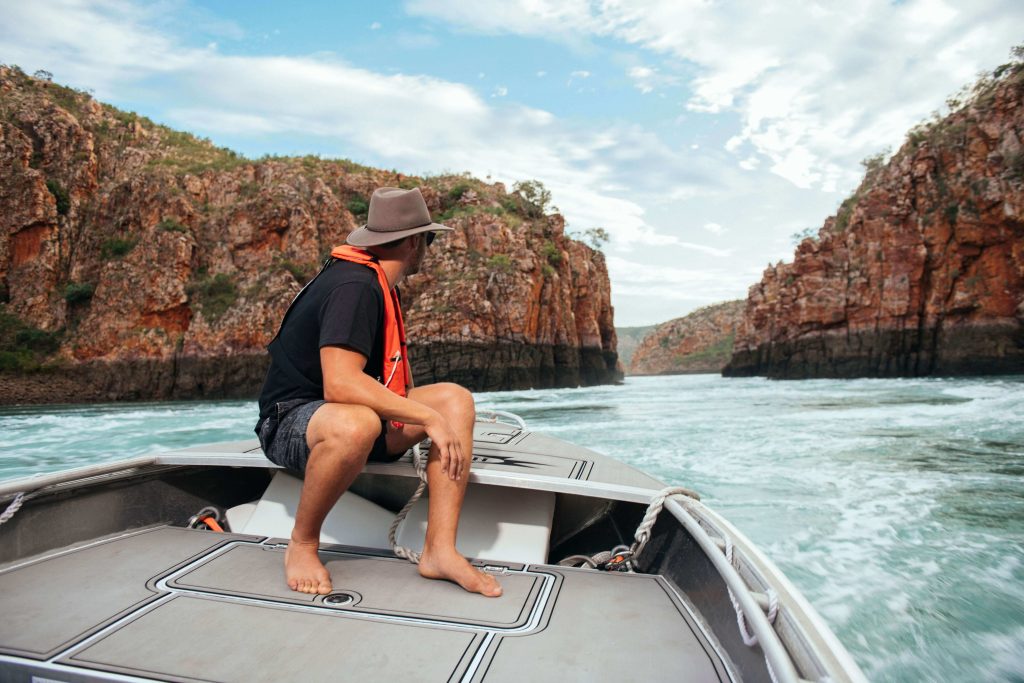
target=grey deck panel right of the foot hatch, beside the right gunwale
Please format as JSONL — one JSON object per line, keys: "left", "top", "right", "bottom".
{"left": 474, "top": 569, "right": 730, "bottom": 683}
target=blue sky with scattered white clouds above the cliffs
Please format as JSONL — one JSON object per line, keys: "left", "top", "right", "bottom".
{"left": 0, "top": 0, "right": 1024, "bottom": 327}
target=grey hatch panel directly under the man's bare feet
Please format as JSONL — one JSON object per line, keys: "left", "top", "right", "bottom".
{"left": 168, "top": 545, "right": 542, "bottom": 629}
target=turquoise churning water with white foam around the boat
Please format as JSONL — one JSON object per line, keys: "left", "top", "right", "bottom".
{"left": 0, "top": 375, "right": 1024, "bottom": 681}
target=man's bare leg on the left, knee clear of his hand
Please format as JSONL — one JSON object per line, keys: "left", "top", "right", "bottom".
{"left": 285, "top": 403, "right": 381, "bottom": 595}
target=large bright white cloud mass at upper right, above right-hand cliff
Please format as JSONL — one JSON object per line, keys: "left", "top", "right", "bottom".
{"left": 411, "top": 0, "right": 1024, "bottom": 191}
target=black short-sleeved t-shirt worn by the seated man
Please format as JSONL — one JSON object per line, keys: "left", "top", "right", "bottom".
{"left": 259, "top": 259, "right": 384, "bottom": 422}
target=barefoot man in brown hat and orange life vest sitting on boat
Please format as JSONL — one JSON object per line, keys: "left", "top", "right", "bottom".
{"left": 256, "top": 187, "right": 502, "bottom": 597}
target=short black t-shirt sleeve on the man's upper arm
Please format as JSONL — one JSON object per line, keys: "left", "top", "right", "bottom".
{"left": 319, "top": 283, "right": 384, "bottom": 358}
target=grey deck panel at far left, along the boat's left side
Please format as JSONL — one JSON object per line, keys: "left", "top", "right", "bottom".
{"left": 0, "top": 527, "right": 230, "bottom": 658}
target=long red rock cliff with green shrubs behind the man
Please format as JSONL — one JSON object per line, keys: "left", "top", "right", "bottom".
{"left": 0, "top": 68, "right": 620, "bottom": 402}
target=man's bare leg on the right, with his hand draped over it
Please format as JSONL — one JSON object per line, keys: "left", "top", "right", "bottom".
{"left": 387, "top": 384, "right": 502, "bottom": 597}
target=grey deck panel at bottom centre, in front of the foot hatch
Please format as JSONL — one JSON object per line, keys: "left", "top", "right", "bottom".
{"left": 61, "top": 596, "right": 481, "bottom": 683}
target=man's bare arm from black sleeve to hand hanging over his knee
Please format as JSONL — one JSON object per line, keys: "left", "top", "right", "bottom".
{"left": 321, "top": 346, "right": 466, "bottom": 479}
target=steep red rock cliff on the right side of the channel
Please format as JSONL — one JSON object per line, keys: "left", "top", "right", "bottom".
{"left": 725, "top": 65, "right": 1024, "bottom": 378}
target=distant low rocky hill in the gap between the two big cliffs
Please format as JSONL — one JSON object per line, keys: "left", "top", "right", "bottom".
{"left": 629, "top": 301, "right": 745, "bottom": 375}
